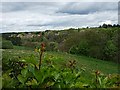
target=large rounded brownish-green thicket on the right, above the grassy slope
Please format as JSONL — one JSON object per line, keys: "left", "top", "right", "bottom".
{"left": 62, "top": 28, "right": 119, "bottom": 62}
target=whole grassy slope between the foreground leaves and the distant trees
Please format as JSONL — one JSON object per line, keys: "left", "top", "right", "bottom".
{"left": 3, "top": 47, "right": 118, "bottom": 74}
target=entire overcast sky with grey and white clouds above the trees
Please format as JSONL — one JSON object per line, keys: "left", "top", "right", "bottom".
{"left": 0, "top": 2, "right": 118, "bottom": 33}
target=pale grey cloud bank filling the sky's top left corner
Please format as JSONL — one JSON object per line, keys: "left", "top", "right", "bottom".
{"left": 0, "top": 2, "right": 64, "bottom": 12}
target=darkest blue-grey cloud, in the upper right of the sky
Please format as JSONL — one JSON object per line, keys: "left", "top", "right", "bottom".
{"left": 57, "top": 2, "right": 118, "bottom": 14}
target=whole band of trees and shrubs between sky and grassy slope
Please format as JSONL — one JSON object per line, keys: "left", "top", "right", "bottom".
{"left": 2, "top": 24, "right": 120, "bottom": 62}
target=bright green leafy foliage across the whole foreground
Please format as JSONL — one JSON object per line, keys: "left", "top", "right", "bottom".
{"left": 2, "top": 50, "right": 119, "bottom": 89}
